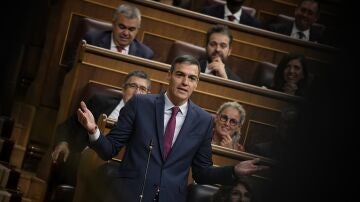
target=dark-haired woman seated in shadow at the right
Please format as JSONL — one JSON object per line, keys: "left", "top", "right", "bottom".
{"left": 272, "top": 53, "right": 309, "bottom": 97}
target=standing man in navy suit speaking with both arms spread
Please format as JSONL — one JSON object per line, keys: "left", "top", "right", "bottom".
{"left": 78, "top": 55, "right": 267, "bottom": 202}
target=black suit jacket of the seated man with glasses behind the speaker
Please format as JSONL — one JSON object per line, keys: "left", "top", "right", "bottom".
{"left": 55, "top": 94, "right": 121, "bottom": 152}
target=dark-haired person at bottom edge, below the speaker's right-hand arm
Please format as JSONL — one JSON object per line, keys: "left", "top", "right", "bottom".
{"left": 212, "top": 180, "right": 253, "bottom": 202}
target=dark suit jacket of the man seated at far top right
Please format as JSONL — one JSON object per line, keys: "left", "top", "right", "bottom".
{"left": 268, "top": 22, "right": 322, "bottom": 42}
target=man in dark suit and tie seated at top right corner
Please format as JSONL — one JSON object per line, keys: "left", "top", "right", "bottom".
{"left": 268, "top": 0, "right": 322, "bottom": 42}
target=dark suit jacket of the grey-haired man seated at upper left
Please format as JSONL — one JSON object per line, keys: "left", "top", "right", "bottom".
{"left": 84, "top": 31, "right": 154, "bottom": 59}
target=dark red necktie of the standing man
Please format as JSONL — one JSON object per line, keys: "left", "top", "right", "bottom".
{"left": 164, "top": 107, "right": 180, "bottom": 159}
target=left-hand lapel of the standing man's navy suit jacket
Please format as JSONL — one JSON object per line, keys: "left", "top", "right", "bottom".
{"left": 155, "top": 94, "right": 165, "bottom": 159}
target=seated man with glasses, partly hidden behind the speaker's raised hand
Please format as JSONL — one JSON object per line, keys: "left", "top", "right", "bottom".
{"left": 51, "top": 71, "right": 151, "bottom": 191}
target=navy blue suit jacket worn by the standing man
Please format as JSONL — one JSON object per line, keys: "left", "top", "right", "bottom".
{"left": 91, "top": 94, "right": 233, "bottom": 202}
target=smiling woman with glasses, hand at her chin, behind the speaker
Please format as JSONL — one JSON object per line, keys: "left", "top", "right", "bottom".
{"left": 212, "top": 102, "right": 246, "bottom": 151}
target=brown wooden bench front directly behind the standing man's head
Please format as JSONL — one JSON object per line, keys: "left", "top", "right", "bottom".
{"left": 57, "top": 44, "right": 302, "bottom": 161}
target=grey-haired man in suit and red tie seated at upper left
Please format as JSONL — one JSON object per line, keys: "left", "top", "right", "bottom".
{"left": 84, "top": 4, "right": 154, "bottom": 59}
